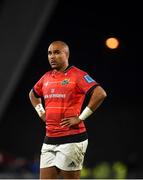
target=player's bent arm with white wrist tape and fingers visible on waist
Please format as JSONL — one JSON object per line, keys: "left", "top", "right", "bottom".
{"left": 61, "top": 86, "right": 107, "bottom": 127}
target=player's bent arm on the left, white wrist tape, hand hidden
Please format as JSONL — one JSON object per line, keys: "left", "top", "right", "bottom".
{"left": 29, "top": 89, "right": 46, "bottom": 122}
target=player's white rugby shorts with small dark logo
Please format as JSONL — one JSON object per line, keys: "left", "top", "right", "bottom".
{"left": 40, "top": 140, "right": 88, "bottom": 171}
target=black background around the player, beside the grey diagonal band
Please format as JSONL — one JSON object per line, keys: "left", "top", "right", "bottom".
{"left": 0, "top": 0, "right": 143, "bottom": 177}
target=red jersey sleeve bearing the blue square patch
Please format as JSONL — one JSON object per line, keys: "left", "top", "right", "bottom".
{"left": 78, "top": 72, "right": 99, "bottom": 94}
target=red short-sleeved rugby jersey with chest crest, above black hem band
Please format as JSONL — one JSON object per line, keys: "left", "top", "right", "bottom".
{"left": 34, "top": 66, "right": 98, "bottom": 137}
